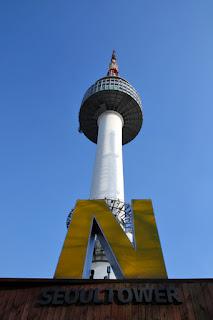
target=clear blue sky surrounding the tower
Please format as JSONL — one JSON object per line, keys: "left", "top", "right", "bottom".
{"left": 0, "top": 0, "right": 213, "bottom": 278}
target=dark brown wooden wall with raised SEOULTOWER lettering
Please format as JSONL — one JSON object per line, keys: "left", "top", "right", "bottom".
{"left": 0, "top": 279, "right": 213, "bottom": 320}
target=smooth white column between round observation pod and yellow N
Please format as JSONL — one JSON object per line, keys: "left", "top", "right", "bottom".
{"left": 90, "top": 111, "right": 124, "bottom": 201}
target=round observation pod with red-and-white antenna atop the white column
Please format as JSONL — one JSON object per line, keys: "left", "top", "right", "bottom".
{"left": 79, "top": 51, "right": 143, "bottom": 144}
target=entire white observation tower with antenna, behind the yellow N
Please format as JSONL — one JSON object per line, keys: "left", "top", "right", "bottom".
{"left": 79, "top": 51, "right": 143, "bottom": 279}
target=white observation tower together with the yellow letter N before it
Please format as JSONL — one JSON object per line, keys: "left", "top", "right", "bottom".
{"left": 54, "top": 51, "right": 167, "bottom": 279}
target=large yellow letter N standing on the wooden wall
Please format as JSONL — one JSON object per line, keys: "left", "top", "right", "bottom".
{"left": 55, "top": 200, "right": 167, "bottom": 279}
